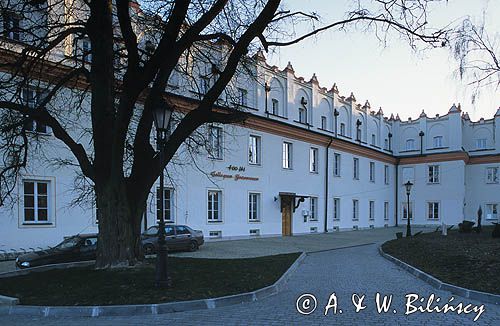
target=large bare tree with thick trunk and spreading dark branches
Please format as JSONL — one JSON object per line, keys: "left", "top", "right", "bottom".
{"left": 0, "top": 0, "right": 447, "bottom": 268}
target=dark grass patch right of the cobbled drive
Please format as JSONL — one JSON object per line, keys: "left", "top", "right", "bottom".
{"left": 382, "top": 226, "right": 500, "bottom": 294}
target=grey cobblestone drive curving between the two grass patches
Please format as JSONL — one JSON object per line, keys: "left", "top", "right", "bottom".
{"left": 0, "top": 245, "right": 500, "bottom": 326}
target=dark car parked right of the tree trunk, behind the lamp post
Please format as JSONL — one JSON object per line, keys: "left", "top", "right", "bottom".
{"left": 142, "top": 225, "right": 205, "bottom": 255}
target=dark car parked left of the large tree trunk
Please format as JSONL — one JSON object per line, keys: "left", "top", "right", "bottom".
{"left": 16, "top": 234, "right": 97, "bottom": 268}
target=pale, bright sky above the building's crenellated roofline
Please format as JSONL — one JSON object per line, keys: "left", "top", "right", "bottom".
{"left": 268, "top": 0, "right": 500, "bottom": 121}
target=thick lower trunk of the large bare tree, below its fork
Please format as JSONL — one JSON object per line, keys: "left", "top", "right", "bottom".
{"left": 96, "top": 180, "right": 144, "bottom": 269}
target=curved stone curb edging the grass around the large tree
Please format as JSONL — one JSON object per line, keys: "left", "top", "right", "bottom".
{"left": 0, "top": 253, "right": 306, "bottom": 317}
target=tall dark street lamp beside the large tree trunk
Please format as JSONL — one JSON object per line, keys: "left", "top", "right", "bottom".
{"left": 153, "top": 101, "right": 172, "bottom": 287}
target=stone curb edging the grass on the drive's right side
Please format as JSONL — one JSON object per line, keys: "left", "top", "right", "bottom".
{"left": 378, "top": 246, "right": 500, "bottom": 305}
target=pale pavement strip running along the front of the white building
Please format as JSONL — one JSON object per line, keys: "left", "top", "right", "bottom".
{"left": 172, "top": 226, "right": 435, "bottom": 259}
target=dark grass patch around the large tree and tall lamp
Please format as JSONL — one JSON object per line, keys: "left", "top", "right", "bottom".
{"left": 0, "top": 253, "right": 300, "bottom": 306}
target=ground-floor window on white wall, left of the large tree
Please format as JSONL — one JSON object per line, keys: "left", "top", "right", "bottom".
{"left": 23, "top": 180, "right": 50, "bottom": 224}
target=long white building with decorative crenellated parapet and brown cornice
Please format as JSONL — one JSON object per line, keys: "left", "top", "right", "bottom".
{"left": 0, "top": 5, "right": 500, "bottom": 251}
